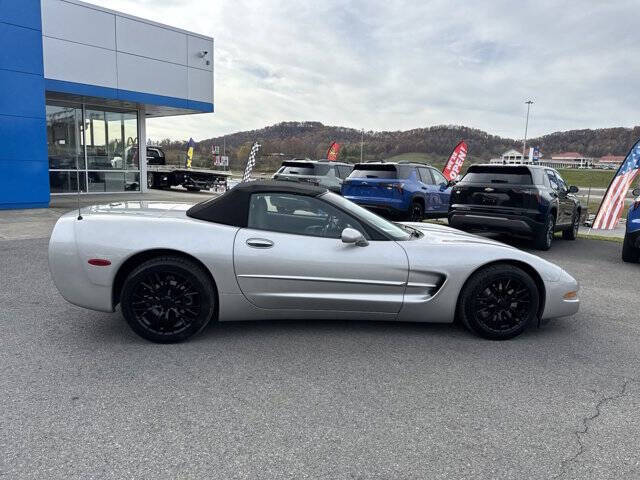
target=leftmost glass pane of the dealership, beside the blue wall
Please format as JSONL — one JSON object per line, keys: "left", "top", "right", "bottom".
{"left": 46, "top": 104, "right": 85, "bottom": 170}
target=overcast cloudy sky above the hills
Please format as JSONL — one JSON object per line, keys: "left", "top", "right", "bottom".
{"left": 90, "top": 0, "right": 640, "bottom": 140}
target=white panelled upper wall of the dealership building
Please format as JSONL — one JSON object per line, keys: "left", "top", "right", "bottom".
{"left": 41, "top": 0, "right": 213, "bottom": 103}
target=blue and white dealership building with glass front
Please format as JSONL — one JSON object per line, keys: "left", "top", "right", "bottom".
{"left": 0, "top": 0, "right": 213, "bottom": 209}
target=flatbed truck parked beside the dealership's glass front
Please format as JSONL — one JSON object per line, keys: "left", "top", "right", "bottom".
{"left": 147, "top": 165, "right": 231, "bottom": 192}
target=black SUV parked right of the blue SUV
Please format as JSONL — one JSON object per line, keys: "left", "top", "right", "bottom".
{"left": 449, "top": 165, "right": 582, "bottom": 250}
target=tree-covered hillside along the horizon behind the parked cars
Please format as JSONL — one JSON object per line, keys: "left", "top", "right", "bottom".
{"left": 155, "top": 122, "right": 640, "bottom": 170}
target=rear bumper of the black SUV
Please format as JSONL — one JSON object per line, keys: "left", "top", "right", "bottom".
{"left": 449, "top": 210, "right": 544, "bottom": 235}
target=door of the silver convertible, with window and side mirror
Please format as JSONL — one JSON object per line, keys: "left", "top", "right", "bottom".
{"left": 233, "top": 193, "right": 408, "bottom": 313}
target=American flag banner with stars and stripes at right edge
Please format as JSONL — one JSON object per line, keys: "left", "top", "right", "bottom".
{"left": 592, "top": 141, "right": 640, "bottom": 230}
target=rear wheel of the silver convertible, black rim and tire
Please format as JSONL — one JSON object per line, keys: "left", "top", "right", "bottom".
{"left": 120, "top": 256, "right": 217, "bottom": 343}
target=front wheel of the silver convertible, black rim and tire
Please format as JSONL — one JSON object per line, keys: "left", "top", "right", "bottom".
{"left": 457, "top": 265, "right": 540, "bottom": 340}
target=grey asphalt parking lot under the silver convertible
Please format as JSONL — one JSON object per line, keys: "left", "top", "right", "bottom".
{"left": 0, "top": 232, "right": 640, "bottom": 479}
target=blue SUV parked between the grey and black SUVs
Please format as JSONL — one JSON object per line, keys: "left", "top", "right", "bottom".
{"left": 342, "top": 162, "right": 451, "bottom": 222}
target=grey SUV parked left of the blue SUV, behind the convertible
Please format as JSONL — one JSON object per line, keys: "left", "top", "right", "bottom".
{"left": 273, "top": 159, "right": 353, "bottom": 193}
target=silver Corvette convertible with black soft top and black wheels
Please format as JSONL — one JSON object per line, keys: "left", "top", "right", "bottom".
{"left": 49, "top": 181, "right": 579, "bottom": 343}
